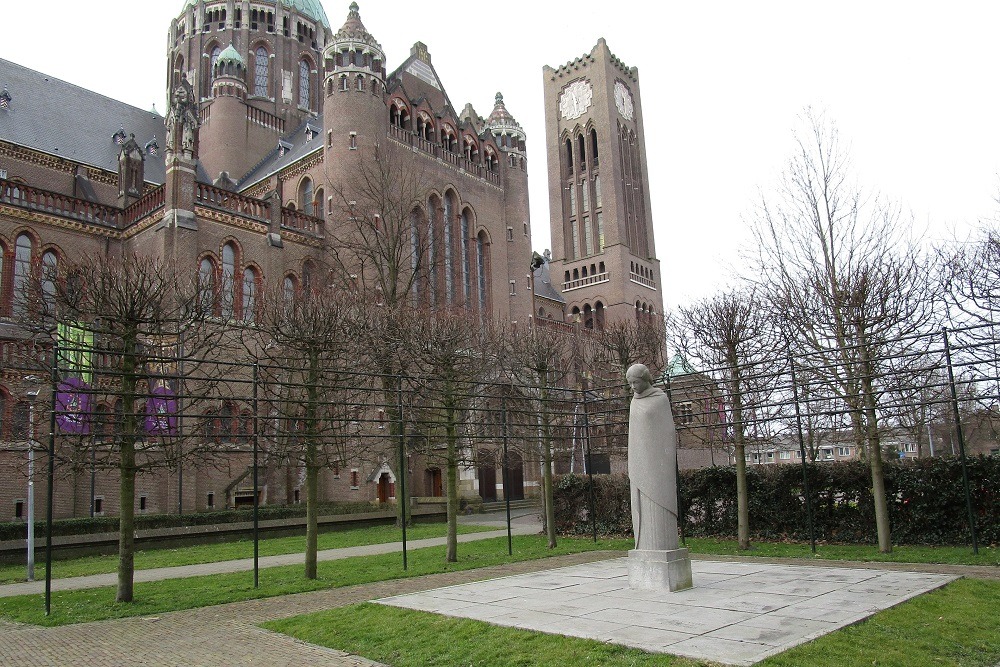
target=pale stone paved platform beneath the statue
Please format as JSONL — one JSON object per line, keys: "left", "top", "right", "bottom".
{"left": 377, "top": 558, "right": 958, "bottom": 665}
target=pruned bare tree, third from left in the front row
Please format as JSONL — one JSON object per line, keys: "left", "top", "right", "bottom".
{"left": 401, "top": 309, "right": 498, "bottom": 563}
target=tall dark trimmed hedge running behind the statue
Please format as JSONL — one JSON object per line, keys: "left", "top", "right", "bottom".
{"left": 555, "top": 456, "right": 1000, "bottom": 545}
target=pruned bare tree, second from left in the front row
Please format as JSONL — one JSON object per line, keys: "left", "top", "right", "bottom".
{"left": 256, "top": 286, "right": 366, "bottom": 579}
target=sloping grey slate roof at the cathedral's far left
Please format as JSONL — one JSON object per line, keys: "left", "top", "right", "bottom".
{"left": 0, "top": 58, "right": 166, "bottom": 185}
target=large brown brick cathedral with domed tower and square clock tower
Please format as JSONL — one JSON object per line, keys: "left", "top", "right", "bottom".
{"left": 0, "top": 0, "right": 662, "bottom": 521}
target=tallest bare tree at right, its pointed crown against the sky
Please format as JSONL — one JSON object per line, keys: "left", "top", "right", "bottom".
{"left": 754, "top": 110, "right": 934, "bottom": 553}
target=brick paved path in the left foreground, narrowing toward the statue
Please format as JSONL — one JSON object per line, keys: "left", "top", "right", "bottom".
{"left": 0, "top": 552, "right": 621, "bottom": 667}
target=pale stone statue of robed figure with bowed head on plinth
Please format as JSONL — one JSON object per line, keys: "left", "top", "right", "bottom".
{"left": 625, "top": 364, "right": 691, "bottom": 591}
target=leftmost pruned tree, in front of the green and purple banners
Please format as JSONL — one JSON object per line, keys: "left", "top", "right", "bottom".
{"left": 36, "top": 254, "right": 219, "bottom": 602}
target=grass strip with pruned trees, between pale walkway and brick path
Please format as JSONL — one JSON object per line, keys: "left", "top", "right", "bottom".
{"left": 0, "top": 535, "right": 632, "bottom": 626}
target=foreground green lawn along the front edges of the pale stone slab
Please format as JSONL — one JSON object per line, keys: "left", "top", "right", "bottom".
{"left": 264, "top": 579, "right": 1000, "bottom": 667}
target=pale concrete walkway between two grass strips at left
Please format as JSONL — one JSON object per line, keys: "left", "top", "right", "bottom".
{"left": 0, "top": 510, "right": 541, "bottom": 596}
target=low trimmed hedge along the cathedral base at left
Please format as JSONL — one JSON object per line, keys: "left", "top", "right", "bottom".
{"left": 0, "top": 503, "right": 375, "bottom": 540}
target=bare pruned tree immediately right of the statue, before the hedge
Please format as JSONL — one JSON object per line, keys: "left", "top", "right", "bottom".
{"left": 675, "top": 287, "right": 780, "bottom": 549}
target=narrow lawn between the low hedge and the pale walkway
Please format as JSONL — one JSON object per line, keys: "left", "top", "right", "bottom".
{"left": 0, "top": 523, "right": 495, "bottom": 584}
